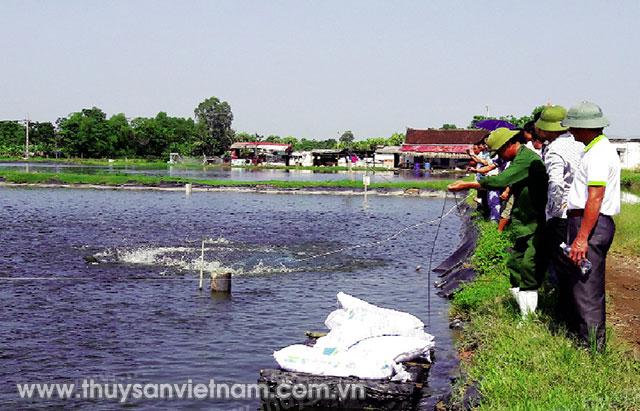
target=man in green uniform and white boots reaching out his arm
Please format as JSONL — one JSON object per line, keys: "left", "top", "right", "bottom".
{"left": 448, "top": 128, "right": 548, "bottom": 316}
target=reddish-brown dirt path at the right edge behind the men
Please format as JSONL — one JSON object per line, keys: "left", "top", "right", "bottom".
{"left": 606, "top": 252, "right": 640, "bottom": 358}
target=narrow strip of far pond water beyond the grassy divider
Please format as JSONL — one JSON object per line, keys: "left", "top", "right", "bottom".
{"left": 0, "top": 162, "right": 455, "bottom": 183}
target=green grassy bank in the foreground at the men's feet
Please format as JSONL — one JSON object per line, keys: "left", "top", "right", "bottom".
{"left": 452, "top": 222, "right": 640, "bottom": 410}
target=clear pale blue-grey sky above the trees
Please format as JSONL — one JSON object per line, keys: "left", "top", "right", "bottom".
{"left": 0, "top": 0, "right": 640, "bottom": 139}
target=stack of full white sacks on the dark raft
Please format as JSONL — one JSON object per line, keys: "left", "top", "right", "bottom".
{"left": 273, "top": 292, "right": 435, "bottom": 381}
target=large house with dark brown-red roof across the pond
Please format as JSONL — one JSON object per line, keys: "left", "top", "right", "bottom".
{"left": 400, "top": 128, "right": 487, "bottom": 169}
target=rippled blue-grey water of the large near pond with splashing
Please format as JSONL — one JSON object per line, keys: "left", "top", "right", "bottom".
{"left": 0, "top": 188, "right": 460, "bottom": 410}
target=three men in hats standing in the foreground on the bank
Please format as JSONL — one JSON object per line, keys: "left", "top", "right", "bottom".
{"left": 449, "top": 102, "right": 620, "bottom": 350}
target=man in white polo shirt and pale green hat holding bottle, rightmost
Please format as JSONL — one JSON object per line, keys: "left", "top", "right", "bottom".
{"left": 559, "top": 101, "right": 620, "bottom": 351}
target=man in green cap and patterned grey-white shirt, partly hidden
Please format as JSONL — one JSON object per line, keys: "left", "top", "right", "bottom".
{"left": 535, "top": 106, "right": 584, "bottom": 323}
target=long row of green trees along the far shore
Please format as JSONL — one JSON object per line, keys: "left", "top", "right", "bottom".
{"left": 0, "top": 97, "right": 404, "bottom": 159}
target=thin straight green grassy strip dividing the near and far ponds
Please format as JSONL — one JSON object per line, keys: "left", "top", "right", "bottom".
{"left": 0, "top": 170, "right": 451, "bottom": 191}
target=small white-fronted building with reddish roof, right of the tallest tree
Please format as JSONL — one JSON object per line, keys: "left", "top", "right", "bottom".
{"left": 230, "top": 141, "right": 292, "bottom": 166}
